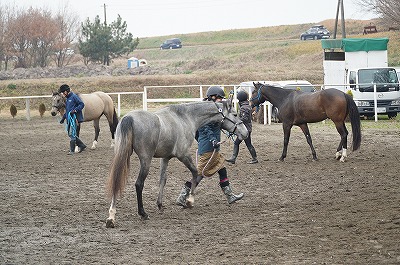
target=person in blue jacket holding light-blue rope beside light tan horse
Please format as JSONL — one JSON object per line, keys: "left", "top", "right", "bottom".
{"left": 58, "top": 84, "right": 86, "bottom": 155}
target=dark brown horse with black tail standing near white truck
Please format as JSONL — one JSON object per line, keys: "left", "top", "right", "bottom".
{"left": 250, "top": 83, "right": 361, "bottom": 162}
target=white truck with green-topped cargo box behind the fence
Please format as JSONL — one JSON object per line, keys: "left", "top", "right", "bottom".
{"left": 321, "top": 38, "right": 400, "bottom": 118}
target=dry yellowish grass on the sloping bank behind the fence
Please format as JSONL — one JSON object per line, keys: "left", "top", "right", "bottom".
{"left": 0, "top": 20, "right": 400, "bottom": 99}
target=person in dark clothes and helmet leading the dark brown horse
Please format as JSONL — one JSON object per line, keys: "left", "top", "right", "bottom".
{"left": 226, "top": 90, "right": 258, "bottom": 164}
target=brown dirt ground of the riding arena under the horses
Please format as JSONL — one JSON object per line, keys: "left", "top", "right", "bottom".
{"left": 0, "top": 117, "right": 400, "bottom": 264}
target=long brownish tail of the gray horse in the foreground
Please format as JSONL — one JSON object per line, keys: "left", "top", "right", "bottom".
{"left": 107, "top": 116, "right": 133, "bottom": 196}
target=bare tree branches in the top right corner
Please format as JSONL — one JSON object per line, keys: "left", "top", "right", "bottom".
{"left": 356, "top": 0, "right": 400, "bottom": 28}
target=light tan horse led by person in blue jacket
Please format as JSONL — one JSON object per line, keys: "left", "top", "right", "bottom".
{"left": 51, "top": 91, "right": 118, "bottom": 149}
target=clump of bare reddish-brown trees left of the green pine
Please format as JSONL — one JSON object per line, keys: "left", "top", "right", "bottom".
{"left": 0, "top": 4, "right": 79, "bottom": 68}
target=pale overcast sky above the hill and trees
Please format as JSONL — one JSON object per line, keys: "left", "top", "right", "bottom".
{"left": 0, "top": 0, "right": 374, "bottom": 38}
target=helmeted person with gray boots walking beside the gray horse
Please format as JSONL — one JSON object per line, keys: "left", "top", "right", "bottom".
{"left": 176, "top": 86, "right": 243, "bottom": 207}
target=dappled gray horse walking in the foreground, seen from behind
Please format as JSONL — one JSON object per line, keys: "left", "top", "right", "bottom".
{"left": 106, "top": 100, "right": 248, "bottom": 227}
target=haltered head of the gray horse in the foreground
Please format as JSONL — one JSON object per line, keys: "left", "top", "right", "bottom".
{"left": 217, "top": 100, "right": 249, "bottom": 140}
